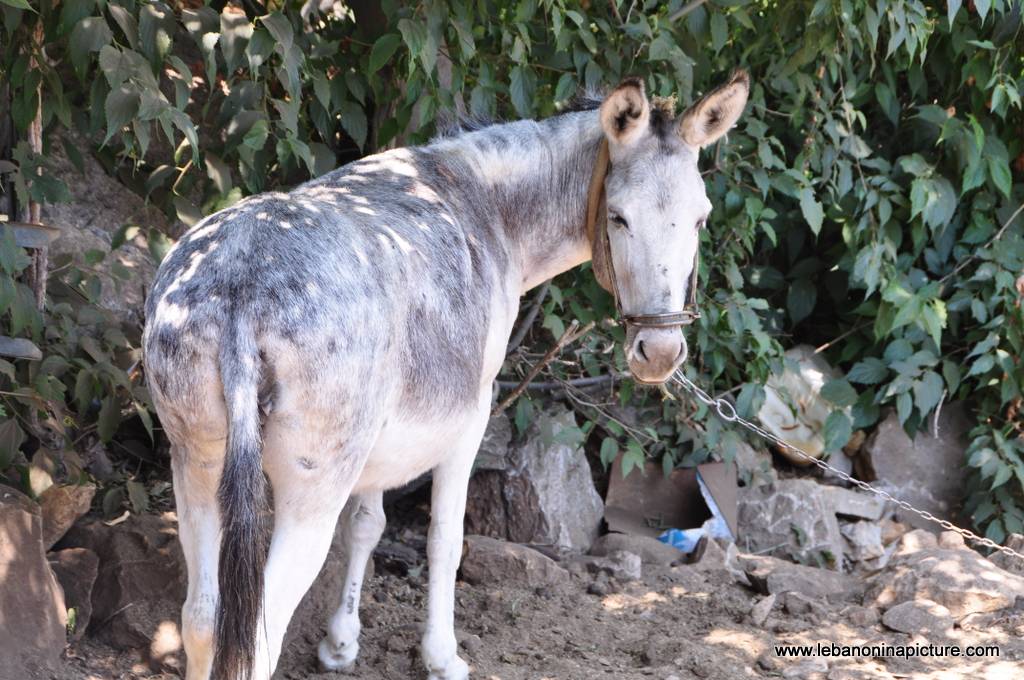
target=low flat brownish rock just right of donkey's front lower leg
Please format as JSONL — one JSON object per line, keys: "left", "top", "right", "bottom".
{"left": 461, "top": 536, "right": 569, "bottom": 588}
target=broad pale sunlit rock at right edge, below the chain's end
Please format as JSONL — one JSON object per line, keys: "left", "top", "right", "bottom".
{"left": 864, "top": 544, "right": 1024, "bottom": 620}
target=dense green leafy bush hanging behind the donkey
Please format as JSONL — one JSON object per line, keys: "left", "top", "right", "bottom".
{"left": 0, "top": 0, "right": 1024, "bottom": 541}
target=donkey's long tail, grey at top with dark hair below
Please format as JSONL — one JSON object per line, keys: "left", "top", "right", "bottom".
{"left": 212, "top": 314, "right": 268, "bottom": 680}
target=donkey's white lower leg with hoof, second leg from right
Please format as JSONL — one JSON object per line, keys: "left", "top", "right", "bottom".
{"left": 317, "top": 492, "right": 386, "bottom": 671}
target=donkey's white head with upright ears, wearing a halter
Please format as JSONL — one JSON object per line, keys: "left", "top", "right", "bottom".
{"left": 592, "top": 72, "right": 750, "bottom": 383}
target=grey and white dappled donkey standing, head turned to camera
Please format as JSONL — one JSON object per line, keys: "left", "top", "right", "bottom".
{"left": 143, "top": 72, "right": 749, "bottom": 680}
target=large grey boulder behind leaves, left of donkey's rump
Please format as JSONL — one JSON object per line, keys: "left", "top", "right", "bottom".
{"left": 41, "top": 130, "right": 167, "bottom": 323}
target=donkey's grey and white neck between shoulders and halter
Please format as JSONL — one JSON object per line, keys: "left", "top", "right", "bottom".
{"left": 432, "top": 111, "right": 603, "bottom": 292}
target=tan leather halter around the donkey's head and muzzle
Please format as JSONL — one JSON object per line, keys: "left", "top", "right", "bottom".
{"left": 587, "top": 139, "right": 700, "bottom": 328}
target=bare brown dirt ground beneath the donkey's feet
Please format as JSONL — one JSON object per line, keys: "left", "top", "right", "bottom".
{"left": 60, "top": 491, "right": 1024, "bottom": 680}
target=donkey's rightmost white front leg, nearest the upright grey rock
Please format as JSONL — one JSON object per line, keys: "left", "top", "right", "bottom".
{"left": 422, "top": 389, "right": 490, "bottom": 680}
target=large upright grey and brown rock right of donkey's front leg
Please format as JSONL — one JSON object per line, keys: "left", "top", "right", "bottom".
{"left": 466, "top": 408, "right": 604, "bottom": 552}
